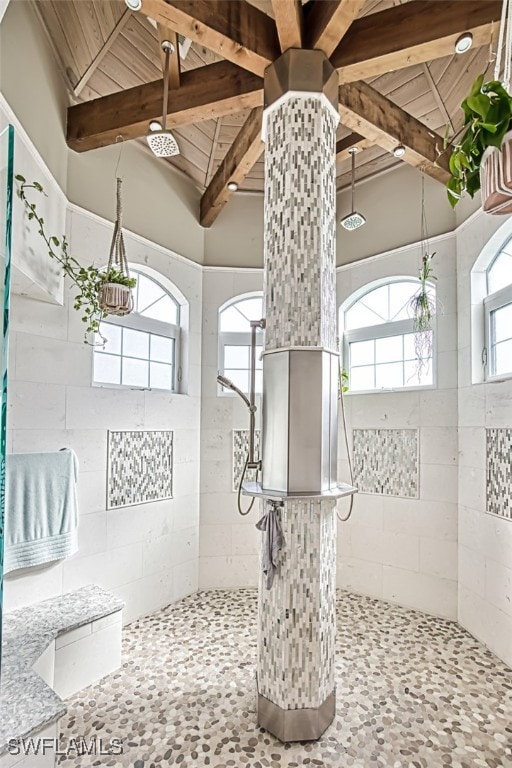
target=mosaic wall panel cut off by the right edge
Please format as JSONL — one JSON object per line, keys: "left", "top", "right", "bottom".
{"left": 486, "top": 428, "right": 512, "bottom": 520}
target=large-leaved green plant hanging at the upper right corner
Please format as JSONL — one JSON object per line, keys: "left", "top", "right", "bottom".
{"left": 445, "top": 74, "right": 512, "bottom": 208}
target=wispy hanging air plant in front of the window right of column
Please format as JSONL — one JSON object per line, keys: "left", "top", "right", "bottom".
{"left": 409, "top": 251, "right": 437, "bottom": 379}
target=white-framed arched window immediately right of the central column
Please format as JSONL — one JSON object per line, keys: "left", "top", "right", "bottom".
{"left": 340, "top": 277, "right": 435, "bottom": 392}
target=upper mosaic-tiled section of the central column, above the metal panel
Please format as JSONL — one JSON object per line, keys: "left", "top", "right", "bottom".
{"left": 264, "top": 94, "right": 338, "bottom": 350}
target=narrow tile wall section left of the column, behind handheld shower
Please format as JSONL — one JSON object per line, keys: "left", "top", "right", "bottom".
{"left": 199, "top": 268, "right": 263, "bottom": 589}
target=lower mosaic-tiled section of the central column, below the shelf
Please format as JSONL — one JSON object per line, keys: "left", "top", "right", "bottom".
{"left": 258, "top": 499, "right": 336, "bottom": 709}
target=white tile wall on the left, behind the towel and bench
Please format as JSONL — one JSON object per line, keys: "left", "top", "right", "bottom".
{"left": 5, "top": 208, "right": 202, "bottom": 621}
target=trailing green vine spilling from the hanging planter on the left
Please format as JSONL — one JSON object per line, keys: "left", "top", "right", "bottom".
{"left": 15, "top": 174, "right": 137, "bottom": 346}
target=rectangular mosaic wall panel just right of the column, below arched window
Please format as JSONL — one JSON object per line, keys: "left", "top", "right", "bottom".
{"left": 353, "top": 429, "right": 419, "bottom": 499}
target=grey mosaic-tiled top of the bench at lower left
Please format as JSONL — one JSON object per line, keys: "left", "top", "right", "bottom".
{"left": 0, "top": 585, "right": 124, "bottom": 755}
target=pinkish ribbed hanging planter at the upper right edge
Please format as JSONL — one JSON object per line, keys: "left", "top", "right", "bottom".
{"left": 480, "top": 131, "right": 512, "bottom": 216}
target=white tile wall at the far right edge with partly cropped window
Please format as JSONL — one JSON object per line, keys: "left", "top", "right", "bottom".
{"left": 457, "top": 208, "right": 512, "bottom": 666}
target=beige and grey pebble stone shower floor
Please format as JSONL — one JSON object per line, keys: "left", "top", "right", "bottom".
{"left": 60, "top": 589, "right": 512, "bottom": 768}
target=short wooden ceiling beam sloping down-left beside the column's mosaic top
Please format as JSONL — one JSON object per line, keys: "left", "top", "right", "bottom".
{"left": 200, "top": 107, "right": 263, "bottom": 227}
